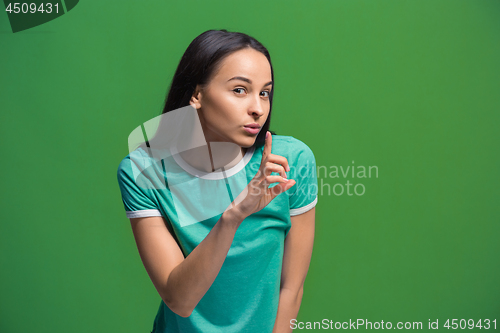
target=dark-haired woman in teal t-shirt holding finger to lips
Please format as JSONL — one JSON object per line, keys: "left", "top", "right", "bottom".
{"left": 118, "top": 30, "right": 317, "bottom": 333}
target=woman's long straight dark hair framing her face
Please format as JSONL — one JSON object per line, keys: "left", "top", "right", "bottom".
{"left": 162, "top": 29, "right": 276, "bottom": 146}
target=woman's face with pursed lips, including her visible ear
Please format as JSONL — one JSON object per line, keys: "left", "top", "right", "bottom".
{"left": 190, "top": 48, "right": 272, "bottom": 148}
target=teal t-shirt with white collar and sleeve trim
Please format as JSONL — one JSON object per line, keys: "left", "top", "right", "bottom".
{"left": 117, "top": 135, "right": 318, "bottom": 333}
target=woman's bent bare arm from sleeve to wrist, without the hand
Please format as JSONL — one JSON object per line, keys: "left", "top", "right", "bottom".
{"left": 130, "top": 210, "right": 244, "bottom": 317}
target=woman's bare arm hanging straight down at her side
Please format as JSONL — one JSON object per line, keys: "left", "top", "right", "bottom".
{"left": 273, "top": 207, "right": 316, "bottom": 333}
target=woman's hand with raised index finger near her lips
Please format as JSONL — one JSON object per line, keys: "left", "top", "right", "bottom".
{"left": 228, "top": 132, "right": 295, "bottom": 219}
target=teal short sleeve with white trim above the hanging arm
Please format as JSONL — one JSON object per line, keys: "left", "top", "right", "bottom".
{"left": 289, "top": 140, "right": 318, "bottom": 216}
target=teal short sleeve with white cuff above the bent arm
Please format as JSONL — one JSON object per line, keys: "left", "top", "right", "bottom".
{"left": 117, "top": 157, "right": 162, "bottom": 218}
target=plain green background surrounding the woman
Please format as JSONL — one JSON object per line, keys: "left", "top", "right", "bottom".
{"left": 0, "top": 0, "right": 500, "bottom": 333}
